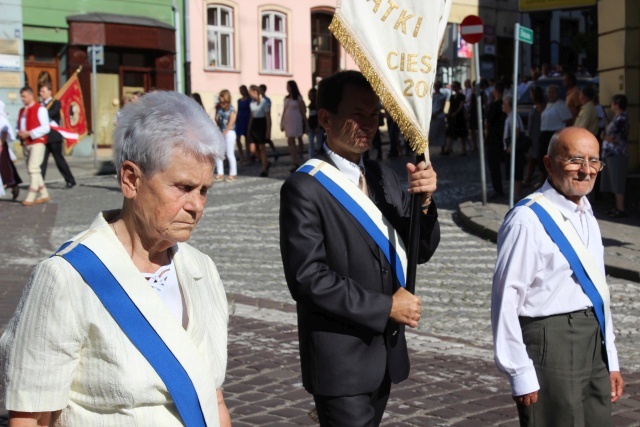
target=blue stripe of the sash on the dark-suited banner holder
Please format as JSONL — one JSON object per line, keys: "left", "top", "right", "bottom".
{"left": 297, "top": 165, "right": 406, "bottom": 288}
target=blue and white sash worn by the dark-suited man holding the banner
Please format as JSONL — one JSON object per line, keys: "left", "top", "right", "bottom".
{"left": 296, "top": 159, "right": 407, "bottom": 288}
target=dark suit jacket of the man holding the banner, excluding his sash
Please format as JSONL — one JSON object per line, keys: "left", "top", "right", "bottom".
{"left": 280, "top": 156, "right": 440, "bottom": 396}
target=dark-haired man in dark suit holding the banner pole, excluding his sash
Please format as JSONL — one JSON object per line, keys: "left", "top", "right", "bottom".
{"left": 280, "top": 71, "right": 440, "bottom": 427}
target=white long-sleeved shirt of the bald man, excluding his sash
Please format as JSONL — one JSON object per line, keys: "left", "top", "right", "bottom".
{"left": 491, "top": 181, "right": 620, "bottom": 396}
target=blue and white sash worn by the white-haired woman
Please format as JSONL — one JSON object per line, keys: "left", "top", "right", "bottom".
{"left": 55, "top": 230, "right": 217, "bottom": 427}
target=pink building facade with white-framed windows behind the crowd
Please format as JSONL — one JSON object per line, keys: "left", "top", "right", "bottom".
{"left": 189, "top": 0, "right": 357, "bottom": 138}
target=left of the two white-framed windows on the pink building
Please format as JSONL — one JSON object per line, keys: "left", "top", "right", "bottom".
{"left": 207, "top": 5, "right": 234, "bottom": 69}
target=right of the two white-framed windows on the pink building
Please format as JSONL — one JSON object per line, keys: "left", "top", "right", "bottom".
{"left": 262, "top": 12, "right": 287, "bottom": 72}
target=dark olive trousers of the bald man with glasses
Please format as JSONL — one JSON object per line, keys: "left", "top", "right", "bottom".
{"left": 518, "top": 309, "right": 611, "bottom": 427}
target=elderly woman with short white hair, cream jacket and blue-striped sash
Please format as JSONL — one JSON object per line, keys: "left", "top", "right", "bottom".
{"left": 0, "top": 92, "right": 231, "bottom": 427}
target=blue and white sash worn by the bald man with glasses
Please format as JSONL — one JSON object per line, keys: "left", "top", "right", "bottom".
{"left": 516, "top": 193, "right": 611, "bottom": 354}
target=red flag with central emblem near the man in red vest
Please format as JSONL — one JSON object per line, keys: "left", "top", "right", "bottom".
{"left": 52, "top": 70, "right": 87, "bottom": 153}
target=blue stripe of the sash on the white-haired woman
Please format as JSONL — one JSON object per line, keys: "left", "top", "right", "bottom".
{"left": 59, "top": 243, "right": 206, "bottom": 427}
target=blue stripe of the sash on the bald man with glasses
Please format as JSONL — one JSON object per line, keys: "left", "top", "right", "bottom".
{"left": 516, "top": 199, "right": 606, "bottom": 343}
